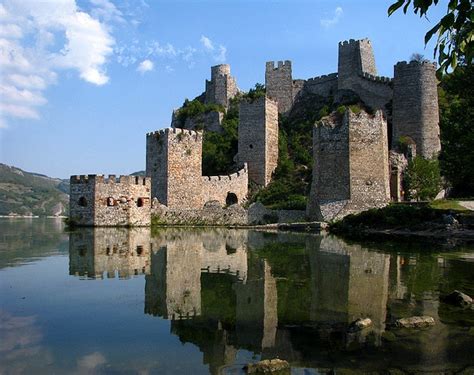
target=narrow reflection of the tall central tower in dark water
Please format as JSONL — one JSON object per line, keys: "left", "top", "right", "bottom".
{"left": 235, "top": 260, "right": 278, "bottom": 350}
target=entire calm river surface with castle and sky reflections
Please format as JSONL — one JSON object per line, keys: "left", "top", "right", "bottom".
{"left": 0, "top": 219, "right": 474, "bottom": 374}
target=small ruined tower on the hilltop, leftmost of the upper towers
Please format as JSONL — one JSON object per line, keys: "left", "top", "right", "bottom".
{"left": 205, "top": 64, "right": 239, "bottom": 108}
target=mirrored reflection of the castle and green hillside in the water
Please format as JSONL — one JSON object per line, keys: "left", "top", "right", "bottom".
{"left": 69, "top": 228, "right": 474, "bottom": 373}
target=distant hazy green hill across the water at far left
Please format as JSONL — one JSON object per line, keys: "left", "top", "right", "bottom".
{"left": 0, "top": 163, "right": 69, "bottom": 216}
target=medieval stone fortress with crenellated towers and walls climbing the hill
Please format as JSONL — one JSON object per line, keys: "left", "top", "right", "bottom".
{"left": 70, "top": 39, "right": 440, "bottom": 226}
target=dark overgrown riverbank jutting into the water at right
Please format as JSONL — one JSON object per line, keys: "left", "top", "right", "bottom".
{"left": 329, "top": 203, "right": 474, "bottom": 245}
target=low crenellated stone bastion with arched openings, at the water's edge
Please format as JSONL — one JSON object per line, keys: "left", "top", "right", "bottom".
{"left": 70, "top": 175, "right": 151, "bottom": 226}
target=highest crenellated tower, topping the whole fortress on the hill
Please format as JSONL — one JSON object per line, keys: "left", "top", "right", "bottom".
{"left": 338, "top": 39, "right": 377, "bottom": 90}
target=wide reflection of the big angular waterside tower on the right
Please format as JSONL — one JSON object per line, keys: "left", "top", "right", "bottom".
{"left": 311, "top": 236, "right": 390, "bottom": 344}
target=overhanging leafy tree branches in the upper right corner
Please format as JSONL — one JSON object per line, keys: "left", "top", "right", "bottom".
{"left": 388, "top": 0, "right": 474, "bottom": 76}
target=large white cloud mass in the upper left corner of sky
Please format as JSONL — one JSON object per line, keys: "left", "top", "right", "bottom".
{"left": 0, "top": 0, "right": 117, "bottom": 127}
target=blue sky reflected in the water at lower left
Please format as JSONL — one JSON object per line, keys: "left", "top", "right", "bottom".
{"left": 0, "top": 256, "right": 214, "bottom": 373}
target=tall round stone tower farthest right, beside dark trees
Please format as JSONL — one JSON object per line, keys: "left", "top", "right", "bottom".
{"left": 392, "top": 61, "right": 441, "bottom": 158}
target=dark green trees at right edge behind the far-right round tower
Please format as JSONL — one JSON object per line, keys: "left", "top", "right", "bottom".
{"left": 439, "top": 65, "right": 474, "bottom": 197}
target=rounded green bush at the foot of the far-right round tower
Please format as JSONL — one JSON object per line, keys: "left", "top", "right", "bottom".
{"left": 403, "top": 156, "right": 441, "bottom": 201}
